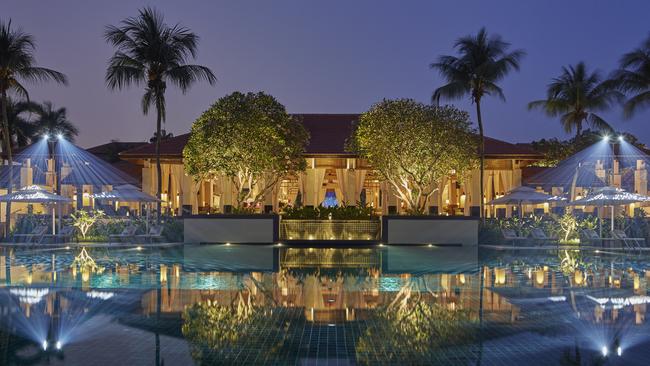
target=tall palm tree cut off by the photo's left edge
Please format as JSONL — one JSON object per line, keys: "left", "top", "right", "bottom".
{"left": 0, "top": 20, "right": 67, "bottom": 233}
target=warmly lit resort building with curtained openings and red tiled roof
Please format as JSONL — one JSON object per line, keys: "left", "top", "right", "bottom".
{"left": 119, "top": 114, "right": 548, "bottom": 216}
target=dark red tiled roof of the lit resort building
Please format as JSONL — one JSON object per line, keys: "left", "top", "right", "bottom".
{"left": 120, "top": 114, "right": 539, "bottom": 158}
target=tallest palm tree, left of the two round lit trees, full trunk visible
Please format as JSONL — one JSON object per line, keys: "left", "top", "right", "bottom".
{"left": 104, "top": 7, "right": 217, "bottom": 219}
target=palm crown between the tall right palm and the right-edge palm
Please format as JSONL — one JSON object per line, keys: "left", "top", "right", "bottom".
{"left": 528, "top": 62, "right": 623, "bottom": 138}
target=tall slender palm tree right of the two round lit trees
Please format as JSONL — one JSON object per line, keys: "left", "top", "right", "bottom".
{"left": 430, "top": 28, "right": 525, "bottom": 217}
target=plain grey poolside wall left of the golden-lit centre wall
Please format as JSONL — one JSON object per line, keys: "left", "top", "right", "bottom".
{"left": 183, "top": 215, "right": 278, "bottom": 244}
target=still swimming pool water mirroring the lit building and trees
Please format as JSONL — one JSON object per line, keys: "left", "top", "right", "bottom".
{"left": 0, "top": 245, "right": 650, "bottom": 365}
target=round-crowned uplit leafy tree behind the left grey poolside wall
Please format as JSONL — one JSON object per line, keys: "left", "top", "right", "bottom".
{"left": 183, "top": 92, "right": 309, "bottom": 208}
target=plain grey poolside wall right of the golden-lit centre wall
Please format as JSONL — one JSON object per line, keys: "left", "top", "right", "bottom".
{"left": 382, "top": 216, "right": 479, "bottom": 246}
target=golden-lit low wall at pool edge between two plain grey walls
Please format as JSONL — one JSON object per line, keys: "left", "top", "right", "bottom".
{"left": 280, "top": 219, "right": 381, "bottom": 241}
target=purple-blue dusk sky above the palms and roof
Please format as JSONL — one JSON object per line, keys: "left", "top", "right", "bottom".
{"left": 5, "top": 0, "right": 650, "bottom": 147}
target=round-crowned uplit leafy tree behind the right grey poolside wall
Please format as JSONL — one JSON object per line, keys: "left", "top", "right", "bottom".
{"left": 348, "top": 99, "right": 477, "bottom": 214}
